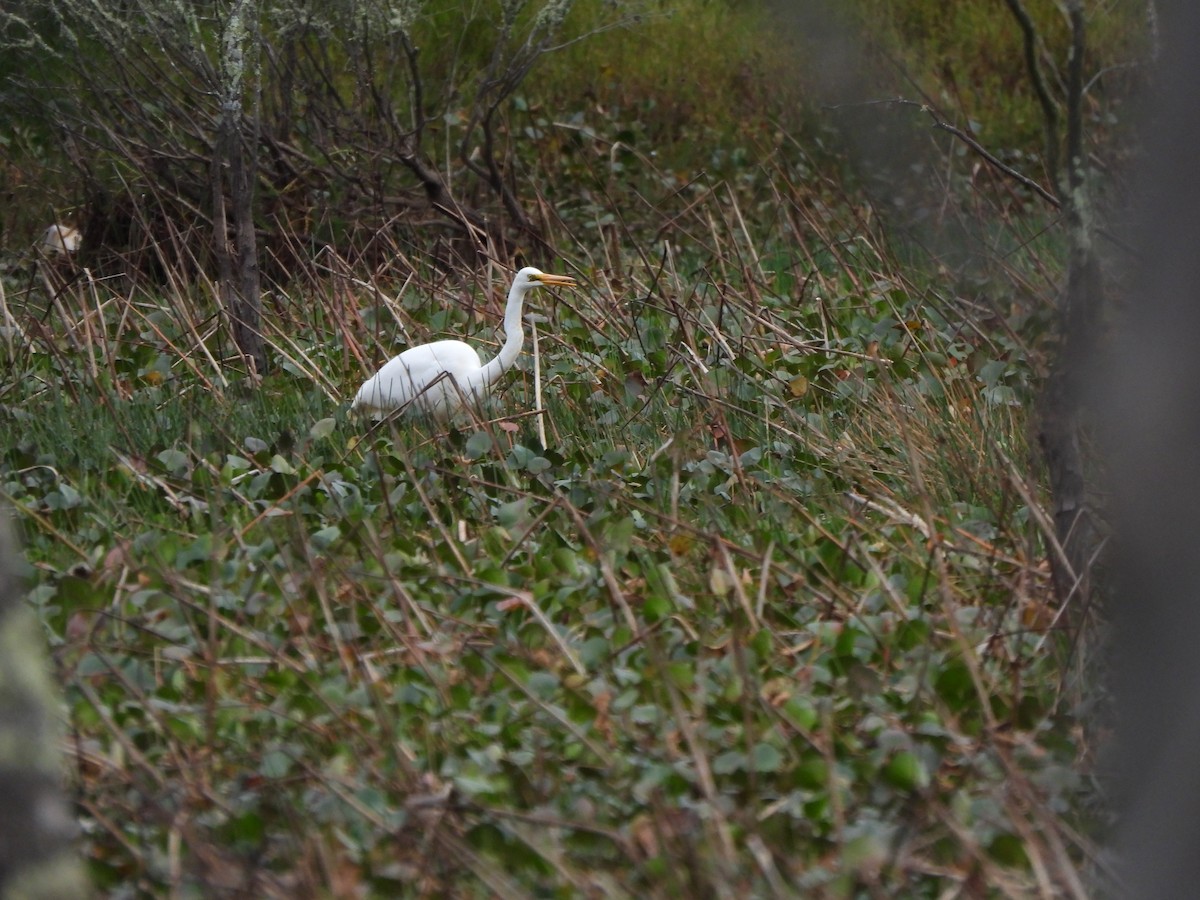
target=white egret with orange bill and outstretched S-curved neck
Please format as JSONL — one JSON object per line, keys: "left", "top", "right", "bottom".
{"left": 350, "top": 266, "right": 575, "bottom": 419}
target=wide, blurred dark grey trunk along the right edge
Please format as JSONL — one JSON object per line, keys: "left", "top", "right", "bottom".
{"left": 1094, "top": 0, "right": 1200, "bottom": 900}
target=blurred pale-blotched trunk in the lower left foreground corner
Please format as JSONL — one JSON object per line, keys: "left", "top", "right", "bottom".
{"left": 0, "top": 522, "right": 89, "bottom": 900}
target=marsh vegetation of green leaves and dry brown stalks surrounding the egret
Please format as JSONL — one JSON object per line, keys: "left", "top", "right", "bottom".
{"left": 0, "top": 0, "right": 1142, "bottom": 898}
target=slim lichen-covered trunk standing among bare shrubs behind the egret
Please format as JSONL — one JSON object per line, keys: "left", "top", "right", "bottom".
{"left": 212, "top": 0, "right": 266, "bottom": 374}
